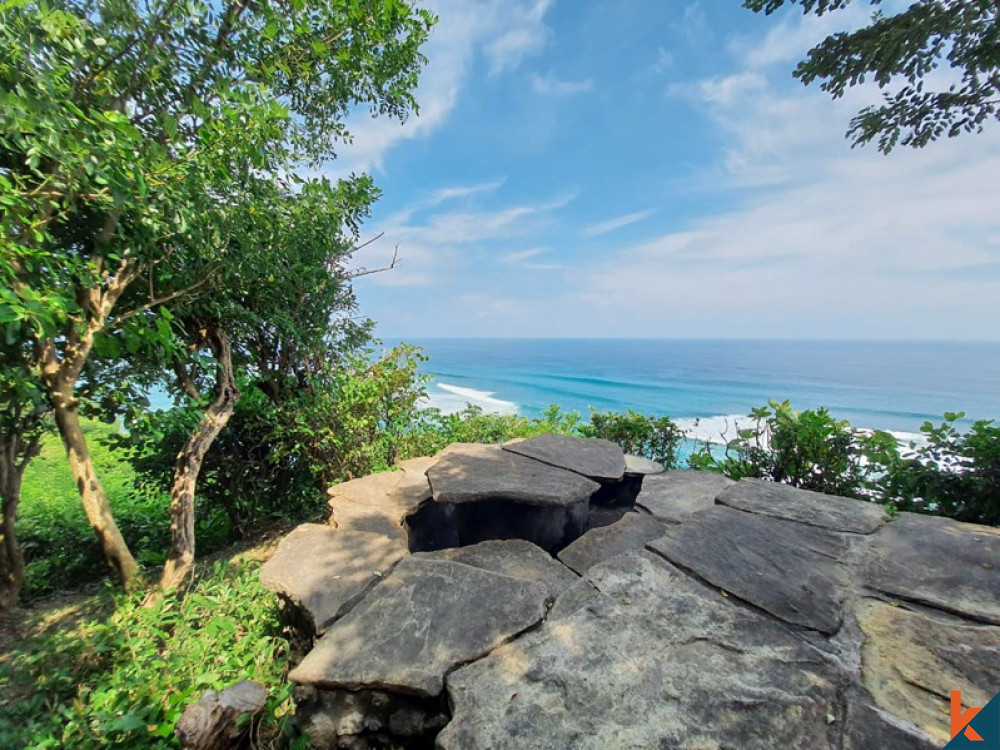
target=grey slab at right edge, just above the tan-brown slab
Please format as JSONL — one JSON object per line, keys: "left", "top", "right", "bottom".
{"left": 868, "top": 513, "right": 1000, "bottom": 625}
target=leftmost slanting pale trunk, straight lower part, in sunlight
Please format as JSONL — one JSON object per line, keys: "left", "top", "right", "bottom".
{"left": 52, "top": 389, "right": 139, "bottom": 589}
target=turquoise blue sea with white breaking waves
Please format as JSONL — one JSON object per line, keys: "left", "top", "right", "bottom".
{"left": 407, "top": 339, "right": 1000, "bottom": 439}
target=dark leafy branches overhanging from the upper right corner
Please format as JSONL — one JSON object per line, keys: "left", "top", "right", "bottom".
{"left": 743, "top": 0, "right": 1000, "bottom": 153}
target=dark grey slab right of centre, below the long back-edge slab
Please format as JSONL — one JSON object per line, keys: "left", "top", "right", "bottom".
{"left": 648, "top": 506, "right": 848, "bottom": 635}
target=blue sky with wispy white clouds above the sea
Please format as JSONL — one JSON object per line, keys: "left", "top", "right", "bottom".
{"left": 326, "top": 0, "right": 1000, "bottom": 340}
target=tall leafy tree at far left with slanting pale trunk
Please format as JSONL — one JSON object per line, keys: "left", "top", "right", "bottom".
{"left": 0, "top": 0, "right": 433, "bottom": 582}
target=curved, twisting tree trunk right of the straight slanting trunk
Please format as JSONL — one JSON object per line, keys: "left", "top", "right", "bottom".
{"left": 160, "top": 326, "right": 240, "bottom": 590}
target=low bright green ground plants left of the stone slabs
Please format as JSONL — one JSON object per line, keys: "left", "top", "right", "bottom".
{"left": 0, "top": 562, "right": 291, "bottom": 750}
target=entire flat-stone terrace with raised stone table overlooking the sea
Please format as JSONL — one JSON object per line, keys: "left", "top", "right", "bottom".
{"left": 261, "top": 438, "right": 1000, "bottom": 750}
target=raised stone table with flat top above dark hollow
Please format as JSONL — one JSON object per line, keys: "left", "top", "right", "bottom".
{"left": 427, "top": 445, "right": 600, "bottom": 552}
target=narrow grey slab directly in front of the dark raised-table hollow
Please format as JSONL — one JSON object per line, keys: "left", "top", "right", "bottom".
{"left": 414, "top": 539, "right": 580, "bottom": 601}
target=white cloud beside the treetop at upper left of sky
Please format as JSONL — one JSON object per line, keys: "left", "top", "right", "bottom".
{"left": 330, "top": 0, "right": 551, "bottom": 175}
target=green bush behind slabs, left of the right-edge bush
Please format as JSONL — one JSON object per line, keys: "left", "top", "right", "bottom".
{"left": 690, "top": 400, "right": 897, "bottom": 499}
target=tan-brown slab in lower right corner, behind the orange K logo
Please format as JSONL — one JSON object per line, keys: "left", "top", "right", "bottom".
{"left": 857, "top": 600, "right": 1000, "bottom": 746}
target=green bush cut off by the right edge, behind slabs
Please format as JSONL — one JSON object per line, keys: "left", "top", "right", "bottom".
{"left": 887, "top": 412, "right": 1000, "bottom": 526}
